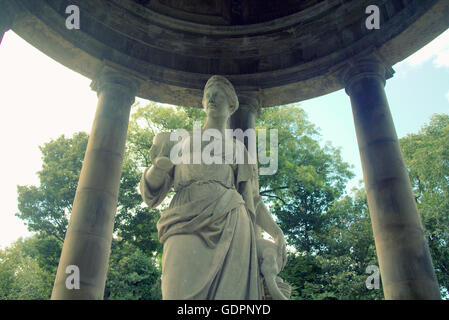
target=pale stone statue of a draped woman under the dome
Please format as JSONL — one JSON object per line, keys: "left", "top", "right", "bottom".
{"left": 140, "top": 76, "right": 286, "bottom": 300}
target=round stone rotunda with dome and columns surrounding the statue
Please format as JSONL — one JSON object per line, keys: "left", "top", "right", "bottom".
{"left": 0, "top": 0, "right": 449, "bottom": 299}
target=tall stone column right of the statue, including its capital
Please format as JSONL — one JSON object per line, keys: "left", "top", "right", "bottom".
{"left": 344, "top": 60, "right": 441, "bottom": 299}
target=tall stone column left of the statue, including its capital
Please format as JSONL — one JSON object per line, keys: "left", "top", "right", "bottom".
{"left": 51, "top": 72, "right": 137, "bottom": 300}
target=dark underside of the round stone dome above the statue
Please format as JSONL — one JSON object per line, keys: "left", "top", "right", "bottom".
{"left": 4, "top": 0, "right": 449, "bottom": 107}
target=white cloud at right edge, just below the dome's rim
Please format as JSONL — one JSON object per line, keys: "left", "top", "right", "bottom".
{"left": 405, "top": 29, "right": 449, "bottom": 67}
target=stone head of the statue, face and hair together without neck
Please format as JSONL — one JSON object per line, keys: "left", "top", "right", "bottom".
{"left": 203, "top": 75, "right": 239, "bottom": 118}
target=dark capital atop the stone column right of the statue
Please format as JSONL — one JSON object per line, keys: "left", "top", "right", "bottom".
{"left": 341, "top": 57, "right": 394, "bottom": 95}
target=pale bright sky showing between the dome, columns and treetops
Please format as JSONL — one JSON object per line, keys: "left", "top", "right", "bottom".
{"left": 0, "top": 31, "right": 449, "bottom": 248}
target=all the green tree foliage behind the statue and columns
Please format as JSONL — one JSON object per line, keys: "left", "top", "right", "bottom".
{"left": 8, "top": 103, "right": 449, "bottom": 299}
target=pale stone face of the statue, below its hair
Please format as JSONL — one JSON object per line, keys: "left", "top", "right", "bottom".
{"left": 203, "top": 83, "right": 231, "bottom": 118}
